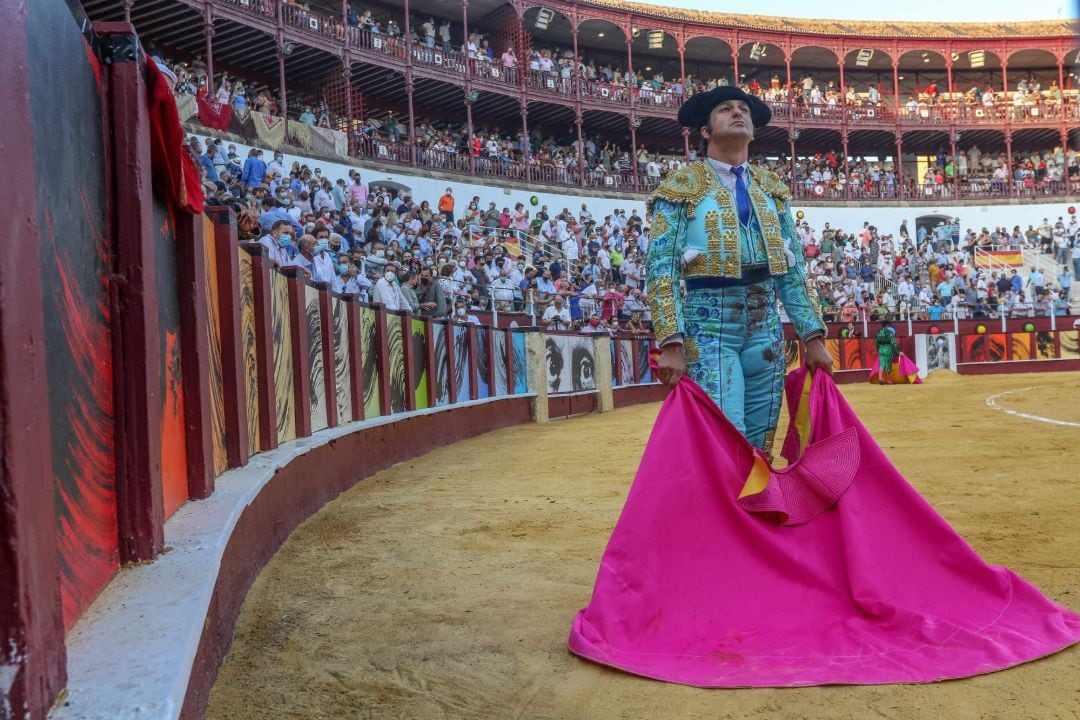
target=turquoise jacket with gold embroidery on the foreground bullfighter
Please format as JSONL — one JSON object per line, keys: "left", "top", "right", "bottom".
{"left": 645, "top": 160, "right": 825, "bottom": 342}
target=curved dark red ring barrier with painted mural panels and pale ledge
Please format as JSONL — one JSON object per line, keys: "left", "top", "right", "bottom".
{"left": 6, "top": 0, "right": 1080, "bottom": 719}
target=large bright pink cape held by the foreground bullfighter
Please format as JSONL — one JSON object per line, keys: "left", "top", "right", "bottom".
{"left": 569, "top": 370, "right": 1080, "bottom": 688}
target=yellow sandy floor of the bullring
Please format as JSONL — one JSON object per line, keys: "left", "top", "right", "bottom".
{"left": 207, "top": 372, "right": 1080, "bottom": 720}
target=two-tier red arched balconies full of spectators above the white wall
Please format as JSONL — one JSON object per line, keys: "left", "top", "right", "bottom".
{"left": 87, "top": 0, "right": 1080, "bottom": 202}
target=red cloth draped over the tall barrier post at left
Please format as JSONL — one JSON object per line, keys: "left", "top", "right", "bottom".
{"left": 146, "top": 57, "right": 203, "bottom": 214}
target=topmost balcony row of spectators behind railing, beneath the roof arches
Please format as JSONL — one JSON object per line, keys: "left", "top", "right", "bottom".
{"left": 190, "top": 0, "right": 1080, "bottom": 134}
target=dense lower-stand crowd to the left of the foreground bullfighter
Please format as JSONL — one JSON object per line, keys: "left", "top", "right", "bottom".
{"left": 188, "top": 136, "right": 650, "bottom": 332}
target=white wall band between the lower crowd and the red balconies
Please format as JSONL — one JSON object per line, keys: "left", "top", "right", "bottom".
{"left": 198, "top": 134, "right": 1080, "bottom": 234}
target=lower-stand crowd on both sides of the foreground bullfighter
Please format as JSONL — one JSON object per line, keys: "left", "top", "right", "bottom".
{"left": 190, "top": 119, "right": 1080, "bottom": 331}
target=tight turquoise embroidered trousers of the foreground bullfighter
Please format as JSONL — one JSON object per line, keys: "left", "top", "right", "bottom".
{"left": 683, "top": 280, "right": 785, "bottom": 454}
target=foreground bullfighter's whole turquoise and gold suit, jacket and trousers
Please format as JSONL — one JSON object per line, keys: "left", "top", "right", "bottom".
{"left": 646, "top": 89, "right": 825, "bottom": 454}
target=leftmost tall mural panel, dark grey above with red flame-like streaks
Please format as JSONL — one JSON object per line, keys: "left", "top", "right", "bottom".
{"left": 34, "top": 2, "right": 119, "bottom": 630}
